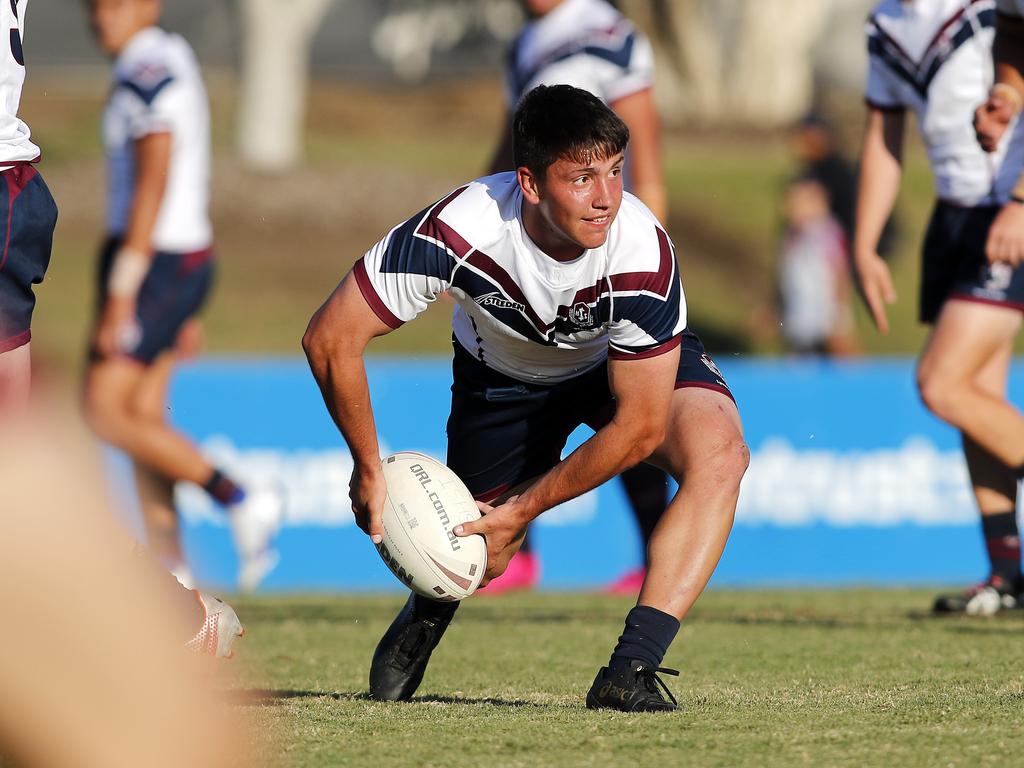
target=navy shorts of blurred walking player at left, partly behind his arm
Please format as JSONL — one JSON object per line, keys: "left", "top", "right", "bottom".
{"left": 90, "top": 238, "right": 213, "bottom": 366}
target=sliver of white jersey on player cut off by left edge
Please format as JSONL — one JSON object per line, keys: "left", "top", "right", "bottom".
{"left": 0, "top": 0, "right": 39, "bottom": 170}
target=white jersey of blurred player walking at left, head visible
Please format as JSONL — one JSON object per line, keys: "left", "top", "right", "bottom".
{"left": 102, "top": 27, "right": 213, "bottom": 253}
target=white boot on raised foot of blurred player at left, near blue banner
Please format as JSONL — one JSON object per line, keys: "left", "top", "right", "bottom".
{"left": 227, "top": 488, "right": 285, "bottom": 592}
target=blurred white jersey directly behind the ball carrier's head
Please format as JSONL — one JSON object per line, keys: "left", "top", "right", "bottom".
{"left": 506, "top": 0, "right": 654, "bottom": 109}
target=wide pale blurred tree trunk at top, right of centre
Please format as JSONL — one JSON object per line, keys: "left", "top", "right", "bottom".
{"left": 620, "top": 0, "right": 831, "bottom": 126}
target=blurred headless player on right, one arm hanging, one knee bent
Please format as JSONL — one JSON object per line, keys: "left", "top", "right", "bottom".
{"left": 854, "top": 0, "right": 1024, "bottom": 613}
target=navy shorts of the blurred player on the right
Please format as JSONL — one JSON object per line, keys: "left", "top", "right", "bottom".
{"left": 921, "top": 201, "right": 1024, "bottom": 324}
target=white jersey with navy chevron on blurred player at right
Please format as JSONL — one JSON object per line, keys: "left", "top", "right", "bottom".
{"left": 866, "top": 0, "right": 1024, "bottom": 206}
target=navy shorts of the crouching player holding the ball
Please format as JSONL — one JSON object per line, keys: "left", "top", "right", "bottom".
{"left": 447, "top": 331, "right": 734, "bottom": 501}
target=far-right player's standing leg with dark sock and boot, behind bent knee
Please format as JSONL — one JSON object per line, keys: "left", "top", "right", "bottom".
{"left": 934, "top": 323, "right": 1021, "bottom": 614}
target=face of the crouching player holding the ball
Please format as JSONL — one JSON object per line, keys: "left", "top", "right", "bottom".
{"left": 519, "top": 153, "right": 624, "bottom": 260}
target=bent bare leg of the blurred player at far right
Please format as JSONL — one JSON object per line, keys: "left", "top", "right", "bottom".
{"left": 918, "top": 299, "right": 1024, "bottom": 469}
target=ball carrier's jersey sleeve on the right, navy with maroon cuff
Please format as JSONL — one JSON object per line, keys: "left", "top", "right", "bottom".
{"left": 608, "top": 227, "right": 686, "bottom": 359}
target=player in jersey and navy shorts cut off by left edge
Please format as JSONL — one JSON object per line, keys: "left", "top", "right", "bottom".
{"left": 0, "top": 0, "right": 57, "bottom": 418}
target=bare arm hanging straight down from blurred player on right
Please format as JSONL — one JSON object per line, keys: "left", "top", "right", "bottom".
{"left": 853, "top": 106, "right": 904, "bottom": 333}
